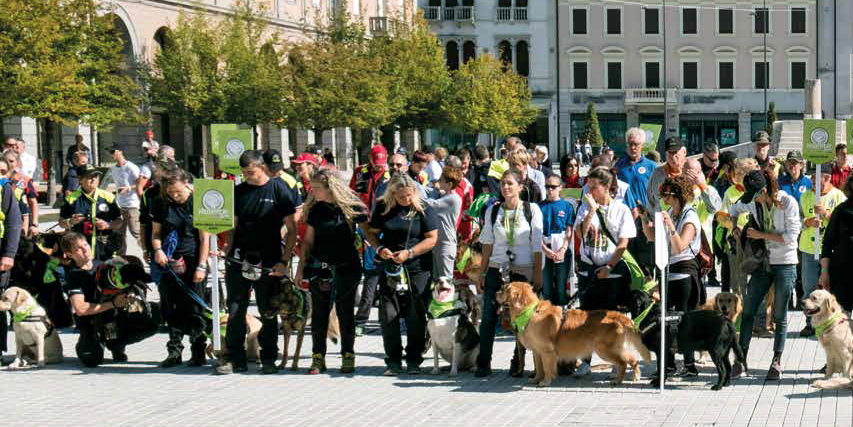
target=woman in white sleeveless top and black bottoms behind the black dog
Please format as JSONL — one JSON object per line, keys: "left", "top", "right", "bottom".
{"left": 643, "top": 175, "right": 702, "bottom": 377}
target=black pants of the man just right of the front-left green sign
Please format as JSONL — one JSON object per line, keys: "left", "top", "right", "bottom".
{"left": 225, "top": 262, "right": 279, "bottom": 366}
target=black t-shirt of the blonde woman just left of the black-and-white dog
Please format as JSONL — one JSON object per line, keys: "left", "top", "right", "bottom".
{"left": 370, "top": 201, "right": 438, "bottom": 273}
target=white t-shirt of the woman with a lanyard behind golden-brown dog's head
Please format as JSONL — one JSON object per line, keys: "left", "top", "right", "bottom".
{"left": 480, "top": 202, "right": 542, "bottom": 266}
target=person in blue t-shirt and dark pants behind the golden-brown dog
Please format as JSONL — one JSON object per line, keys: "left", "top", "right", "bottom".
{"left": 539, "top": 174, "right": 575, "bottom": 305}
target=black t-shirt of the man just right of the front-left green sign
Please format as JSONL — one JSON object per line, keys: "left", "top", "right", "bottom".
{"left": 231, "top": 179, "right": 296, "bottom": 267}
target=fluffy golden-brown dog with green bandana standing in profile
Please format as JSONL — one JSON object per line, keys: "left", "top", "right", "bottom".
{"left": 496, "top": 282, "right": 651, "bottom": 387}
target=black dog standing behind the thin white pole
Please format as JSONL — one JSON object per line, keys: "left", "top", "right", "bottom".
{"left": 630, "top": 291, "right": 747, "bottom": 390}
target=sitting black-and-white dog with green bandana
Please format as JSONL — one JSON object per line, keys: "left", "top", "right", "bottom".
{"left": 427, "top": 277, "right": 480, "bottom": 376}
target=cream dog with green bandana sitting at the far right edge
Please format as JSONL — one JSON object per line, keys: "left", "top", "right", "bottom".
{"left": 803, "top": 289, "right": 853, "bottom": 389}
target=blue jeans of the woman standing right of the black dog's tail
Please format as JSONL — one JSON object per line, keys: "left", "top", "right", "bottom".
{"left": 740, "top": 264, "right": 797, "bottom": 354}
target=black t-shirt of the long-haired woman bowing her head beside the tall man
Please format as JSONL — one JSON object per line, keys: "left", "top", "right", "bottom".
{"left": 305, "top": 202, "right": 367, "bottom": 265}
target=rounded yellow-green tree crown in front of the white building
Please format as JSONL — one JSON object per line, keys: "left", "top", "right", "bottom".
{"left": 441, "top": 54, "right": 538, "bottom": 141}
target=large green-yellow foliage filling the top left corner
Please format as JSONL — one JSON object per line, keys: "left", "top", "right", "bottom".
{"left": 0, "top": 0, "right": 143, "bottom": 128}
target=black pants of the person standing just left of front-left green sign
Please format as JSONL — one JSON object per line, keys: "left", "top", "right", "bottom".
{"left": 158, "top": 257, "right": 211, "bottom": 357}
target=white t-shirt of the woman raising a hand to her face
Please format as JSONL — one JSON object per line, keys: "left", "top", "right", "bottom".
{"left": 575, "top": 200, "right": 637, "bottom": 268}
